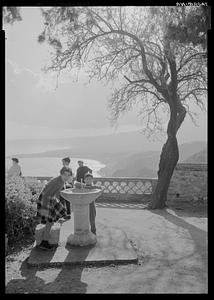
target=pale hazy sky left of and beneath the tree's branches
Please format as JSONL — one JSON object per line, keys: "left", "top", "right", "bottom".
{"left": 4, "top": 7, "right": 207, "bottom": 142}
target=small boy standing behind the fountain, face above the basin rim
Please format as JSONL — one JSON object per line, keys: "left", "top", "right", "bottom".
{"left": 83, "top": 173, "right": 102, "bottom": 234}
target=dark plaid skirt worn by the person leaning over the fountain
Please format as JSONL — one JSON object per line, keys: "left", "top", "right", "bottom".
{"left": 37, "top": 194, "right": 66, "bottom": 224}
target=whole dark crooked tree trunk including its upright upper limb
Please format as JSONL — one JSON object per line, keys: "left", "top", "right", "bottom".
{"left": 149, "top": 39, "right": 186, "bottom": 209}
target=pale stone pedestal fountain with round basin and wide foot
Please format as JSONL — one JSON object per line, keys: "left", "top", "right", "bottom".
{"left": 61, "top": 188, "right": 102, "bottom": 246}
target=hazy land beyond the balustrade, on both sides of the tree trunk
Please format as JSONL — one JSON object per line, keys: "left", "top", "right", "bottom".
{"left": 8, "top": 131, "right": 206, "bottom": 177}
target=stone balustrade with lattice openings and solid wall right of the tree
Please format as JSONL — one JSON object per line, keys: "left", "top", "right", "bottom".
{"left": 25, "top": 163, "right": 207, "bottom": 202}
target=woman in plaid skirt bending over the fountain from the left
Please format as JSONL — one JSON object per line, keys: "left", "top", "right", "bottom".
{"left": 37, "top": 167, "right": 72, "bottom": 250}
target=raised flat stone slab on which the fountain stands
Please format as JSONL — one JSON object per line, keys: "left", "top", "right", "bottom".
{"left": 28, "top": 219, "right": 138, "bottom": 267}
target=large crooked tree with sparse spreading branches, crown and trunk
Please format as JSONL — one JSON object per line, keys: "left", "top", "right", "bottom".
{"left": 3, "top": 7, "right": 207, "bottom": 209}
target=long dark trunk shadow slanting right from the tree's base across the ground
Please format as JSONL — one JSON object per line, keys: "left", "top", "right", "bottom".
{"left": 150, "top": 208, "right": 208, "bottom": 260}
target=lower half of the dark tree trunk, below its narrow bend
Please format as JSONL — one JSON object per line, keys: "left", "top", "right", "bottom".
{"left": 149, "top": 135, "right": 179, "bottom": 209}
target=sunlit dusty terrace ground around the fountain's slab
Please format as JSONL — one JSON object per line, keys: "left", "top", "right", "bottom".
{"left": 6, "top": 206, "right": 207, "bottom": 294}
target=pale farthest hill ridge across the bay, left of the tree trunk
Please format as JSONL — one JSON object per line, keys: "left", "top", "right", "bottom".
{"left": 6, "top": 131, "right": 161, "bottom": 159}
